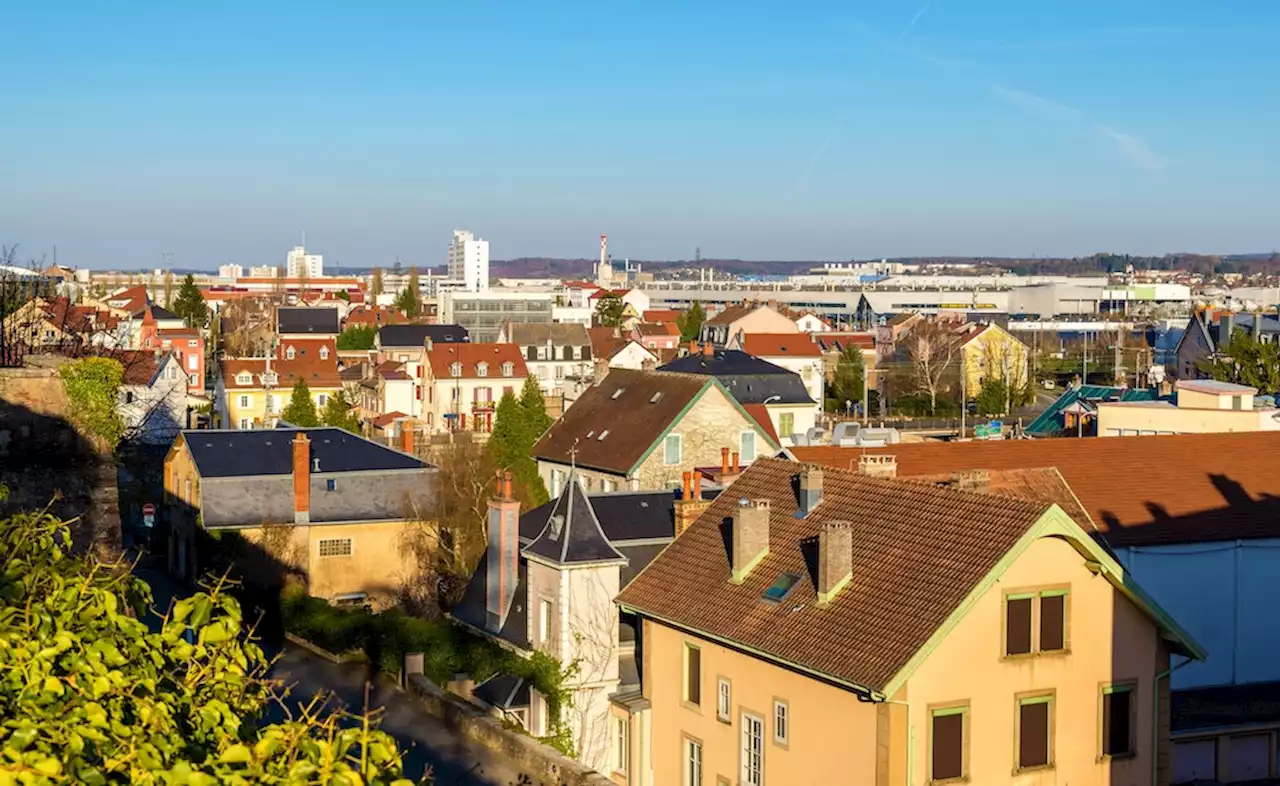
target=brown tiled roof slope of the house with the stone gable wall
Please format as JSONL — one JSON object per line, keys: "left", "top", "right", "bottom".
{"left": 532, "top": 369, "right": 714, "bottom": 474}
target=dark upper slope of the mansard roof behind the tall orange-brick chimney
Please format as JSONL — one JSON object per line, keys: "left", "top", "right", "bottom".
{"left": 182, "top": 426, "right": 430, "bottom": 480}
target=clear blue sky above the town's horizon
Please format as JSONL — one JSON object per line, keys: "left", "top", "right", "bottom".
{"left": 0, "top": 0, "right": 1280, "bottom": 268}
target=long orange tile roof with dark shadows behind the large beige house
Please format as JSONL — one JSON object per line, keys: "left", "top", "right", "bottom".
{"left": 791, "top": 431, "right": 1280, "bottom": 548}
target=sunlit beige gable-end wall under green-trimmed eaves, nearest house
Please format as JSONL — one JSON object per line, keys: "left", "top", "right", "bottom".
{"left": 906, "top": 538, "right": 1167, "bottom": 786}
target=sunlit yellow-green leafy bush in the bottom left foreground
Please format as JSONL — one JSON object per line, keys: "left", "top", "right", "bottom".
{"left": 0, "top": 512, "right": 430, "bottom": 786}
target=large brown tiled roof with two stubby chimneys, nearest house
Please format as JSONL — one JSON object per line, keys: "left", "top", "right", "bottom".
{"left": 618, "top": 458, "right": 1047, "bottom": 691}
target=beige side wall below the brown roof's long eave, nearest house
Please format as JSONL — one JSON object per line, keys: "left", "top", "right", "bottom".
{"left": 643, "top": 621, "right": 878, "bottom": 786}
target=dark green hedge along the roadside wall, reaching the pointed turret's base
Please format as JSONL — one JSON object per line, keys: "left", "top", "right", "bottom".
{"left": 280, "top": 588, "right": 576, "bottom": 755}
